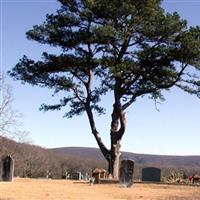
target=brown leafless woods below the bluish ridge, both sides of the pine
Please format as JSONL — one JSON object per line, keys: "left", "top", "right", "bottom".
{"left": 0, "top": 137, "right": 200, "bottom": 180}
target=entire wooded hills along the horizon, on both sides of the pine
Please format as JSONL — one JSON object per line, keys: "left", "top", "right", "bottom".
{"left": 0, "top": 137, "right": 200, "bottom": 178}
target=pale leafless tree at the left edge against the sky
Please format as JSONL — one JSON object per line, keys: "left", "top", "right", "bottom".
{"left": 0, "top": 72, "right": 30, "bottom": 155}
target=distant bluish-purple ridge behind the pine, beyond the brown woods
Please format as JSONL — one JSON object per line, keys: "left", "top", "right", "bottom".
{"left": 52, "top": 147, "right": 200, "bottom": 169}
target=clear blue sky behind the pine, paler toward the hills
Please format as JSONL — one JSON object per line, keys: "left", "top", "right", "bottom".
{"left": 0, "top": 0, "right": 200, "bottom": 155}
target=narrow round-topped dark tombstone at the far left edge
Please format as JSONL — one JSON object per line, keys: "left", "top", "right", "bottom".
{"left": 0, "top": 155, "right": 14, "bottom": 182}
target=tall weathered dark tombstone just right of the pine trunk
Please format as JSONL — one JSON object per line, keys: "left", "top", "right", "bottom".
{"left": 119, "top": 160, "right": 134, "bottom": 187}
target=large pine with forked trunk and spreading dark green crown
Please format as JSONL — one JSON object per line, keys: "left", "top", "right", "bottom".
{"left": 9, "top": 0, "right": 200, "bottom": 178}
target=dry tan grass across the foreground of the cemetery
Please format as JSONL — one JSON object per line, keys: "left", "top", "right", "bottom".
{"left": 0, "top": 179, "right": 200, "bottom": 200}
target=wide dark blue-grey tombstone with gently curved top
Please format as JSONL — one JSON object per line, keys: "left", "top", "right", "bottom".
{"left": 142, "top": 167, "right": 161, "bottom": 182}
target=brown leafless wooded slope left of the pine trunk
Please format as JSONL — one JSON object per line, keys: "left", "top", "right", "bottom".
{"left": 0, "top": 136, "right": 105, "bottom": 179}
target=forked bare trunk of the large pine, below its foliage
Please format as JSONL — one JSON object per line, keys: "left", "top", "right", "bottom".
{"left": 85, "top": 83, "right": 126, "bottom": 179}
